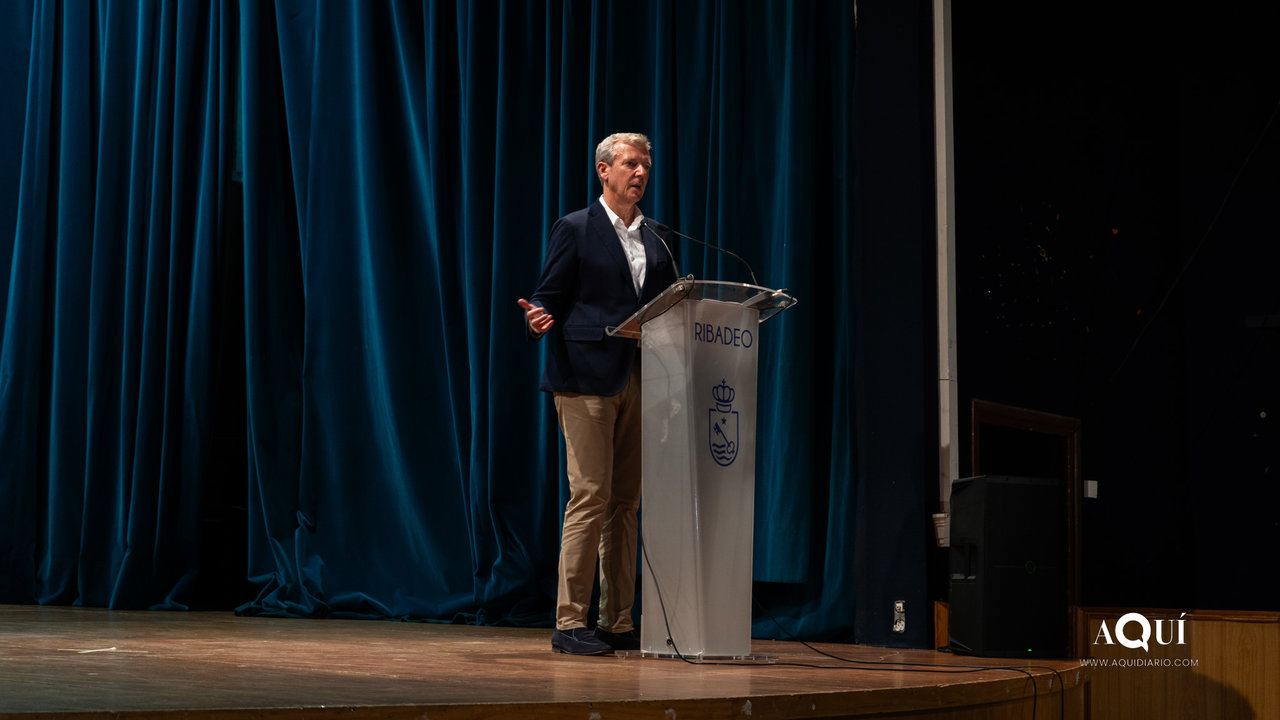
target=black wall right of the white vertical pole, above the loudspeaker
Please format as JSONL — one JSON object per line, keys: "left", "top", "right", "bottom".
{"left": 954, "top": 4, "right": 1280, "bottom": 610}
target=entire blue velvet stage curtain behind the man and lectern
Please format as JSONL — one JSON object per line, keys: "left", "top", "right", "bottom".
{"left": 0, "top": 0, "right": 936, "bottom": 644}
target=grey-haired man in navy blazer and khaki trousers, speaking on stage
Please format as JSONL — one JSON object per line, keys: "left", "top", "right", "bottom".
{"left": 520, "top": 133, "right": 676, "bottom": 655}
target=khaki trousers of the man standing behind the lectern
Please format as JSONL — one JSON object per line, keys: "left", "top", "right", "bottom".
{"left": 556, "top": 364, "right": 640, "bottom": 633}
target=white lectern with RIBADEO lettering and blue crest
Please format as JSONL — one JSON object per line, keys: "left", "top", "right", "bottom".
{"left": 609, "top": 275, "right": 796, "bottom": 660}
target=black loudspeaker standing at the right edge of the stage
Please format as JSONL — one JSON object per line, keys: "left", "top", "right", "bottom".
{"left": 947, "top": 475, "right": 1068, "bottom": 657}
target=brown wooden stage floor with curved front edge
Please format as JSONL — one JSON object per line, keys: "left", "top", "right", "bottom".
{"left": 0, "top": 606, "right": 1088, "bottom": 720}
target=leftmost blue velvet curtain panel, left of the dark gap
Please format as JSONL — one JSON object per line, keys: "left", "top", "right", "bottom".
{"left": 0, "top": 1, "right": 234, "bottom": 607}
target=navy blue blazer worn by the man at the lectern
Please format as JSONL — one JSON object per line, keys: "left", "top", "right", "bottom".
{"left": 529, "top": 200, "right": 676, "bottom": 396}
